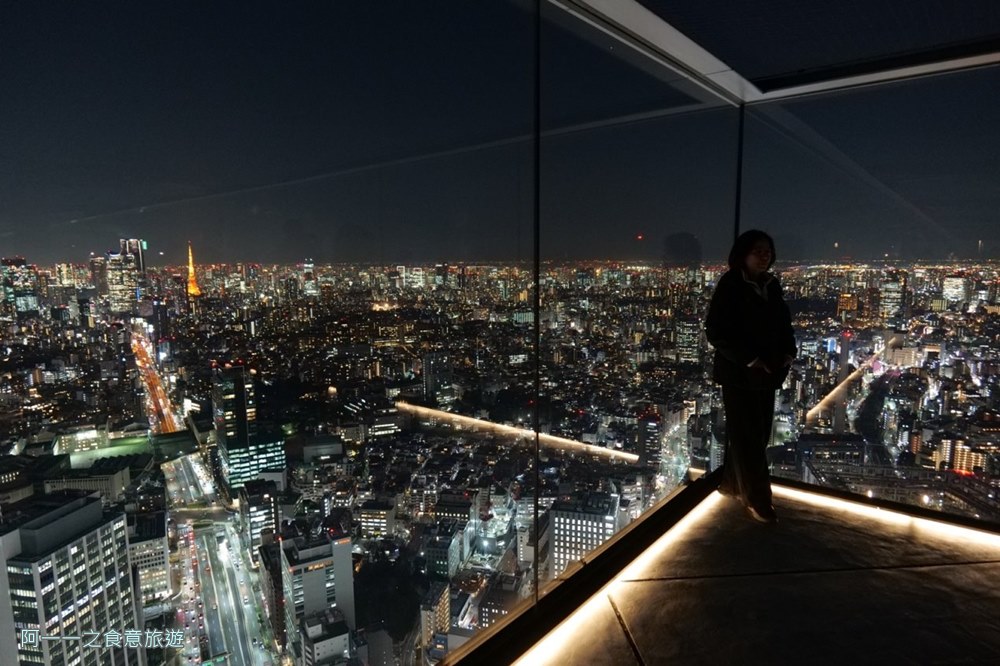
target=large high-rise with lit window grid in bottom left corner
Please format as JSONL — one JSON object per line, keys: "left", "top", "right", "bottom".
{"left": 0, "top": 491, "right": 146, "bottom": 666}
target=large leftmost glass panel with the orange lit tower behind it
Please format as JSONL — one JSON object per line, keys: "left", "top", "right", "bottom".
{"left": 0, "top": 0, "right": 536, "bottom": 664}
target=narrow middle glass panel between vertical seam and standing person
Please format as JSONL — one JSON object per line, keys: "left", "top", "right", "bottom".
{"left": 536, "top": 5, "right": 738, "bottom": 586}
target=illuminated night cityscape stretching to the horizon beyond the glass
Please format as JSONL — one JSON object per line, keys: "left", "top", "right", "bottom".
{"left": 0, "top": 240, "right": 1000, "bottom": 664}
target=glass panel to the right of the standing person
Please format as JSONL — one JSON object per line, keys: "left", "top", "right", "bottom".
{"left": 743, "top": 68, "right": 1000, "bottom": 521}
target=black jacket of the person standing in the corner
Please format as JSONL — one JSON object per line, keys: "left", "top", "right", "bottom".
{"left": 705, "top": 270, "right": 795, "bottom": 390}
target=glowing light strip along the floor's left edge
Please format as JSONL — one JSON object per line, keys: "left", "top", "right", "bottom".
{"left": 514, "top": 493, "right": 723, "bottom": 666}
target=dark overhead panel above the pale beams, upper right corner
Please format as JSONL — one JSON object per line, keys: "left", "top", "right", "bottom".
{"left": 640, "top": 0, "right": 1000, "bottom": 90}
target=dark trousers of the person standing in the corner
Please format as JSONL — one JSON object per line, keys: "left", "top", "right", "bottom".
{"left": 722, "top": 386, "right": 775, "bottom": 508}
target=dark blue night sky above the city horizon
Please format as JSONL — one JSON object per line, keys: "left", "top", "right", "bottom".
{"left": 0, "top": 0, "right": 1000, "bottom": 264}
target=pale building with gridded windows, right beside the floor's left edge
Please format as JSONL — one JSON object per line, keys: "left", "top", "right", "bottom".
{"left": 551, "top": 492, "right": 619, "bottom": 576}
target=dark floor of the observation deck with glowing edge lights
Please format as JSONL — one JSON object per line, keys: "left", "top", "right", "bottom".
{"left": 524, "top": 488, "right": 1000, "bottom": 666}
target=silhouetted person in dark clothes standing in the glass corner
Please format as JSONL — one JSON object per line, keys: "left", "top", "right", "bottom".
{"left": 705, "top": 230, "right": 795, "bottom": 523}
